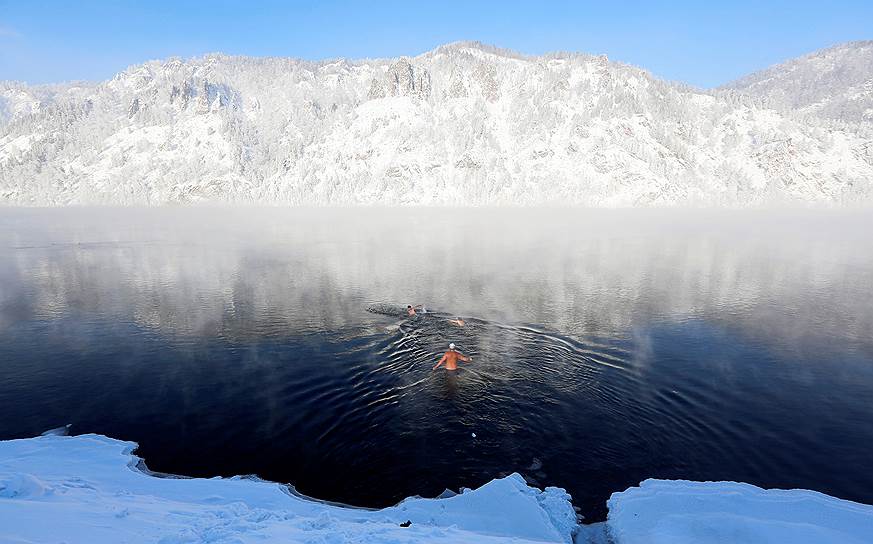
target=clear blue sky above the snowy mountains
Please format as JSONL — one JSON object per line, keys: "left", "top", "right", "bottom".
{"left": 0, "top": 0, "right": 873, "bottom": 87}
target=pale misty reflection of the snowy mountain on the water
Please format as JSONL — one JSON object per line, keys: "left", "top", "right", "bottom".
{"left": 0, "top": 210, "right": 873, "bottom": 356}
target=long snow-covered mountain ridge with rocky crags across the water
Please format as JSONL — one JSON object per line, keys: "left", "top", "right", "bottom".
{"left": 0, "top": 43, "right": 873, "bottom": 207}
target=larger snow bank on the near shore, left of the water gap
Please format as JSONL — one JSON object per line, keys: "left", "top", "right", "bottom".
{"left": 0, "top": 435, "right": 578, "bottom": 544}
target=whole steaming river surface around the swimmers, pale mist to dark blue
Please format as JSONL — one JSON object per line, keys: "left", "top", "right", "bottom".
{"left": 0, "top": 209, "right": 873, "bottom": 520}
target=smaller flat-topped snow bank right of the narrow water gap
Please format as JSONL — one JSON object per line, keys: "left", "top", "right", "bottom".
{"left": 607, "top": 480, "right": 873, "bottom": 544}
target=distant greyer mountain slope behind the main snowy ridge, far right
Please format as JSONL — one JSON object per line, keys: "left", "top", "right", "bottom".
{"left": 724, "top": 41, "right": 873, "bottom": 123}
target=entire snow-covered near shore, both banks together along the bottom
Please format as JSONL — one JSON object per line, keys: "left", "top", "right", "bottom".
{"left": 0, "top": 435, "right": 873, "bottom": 544}
